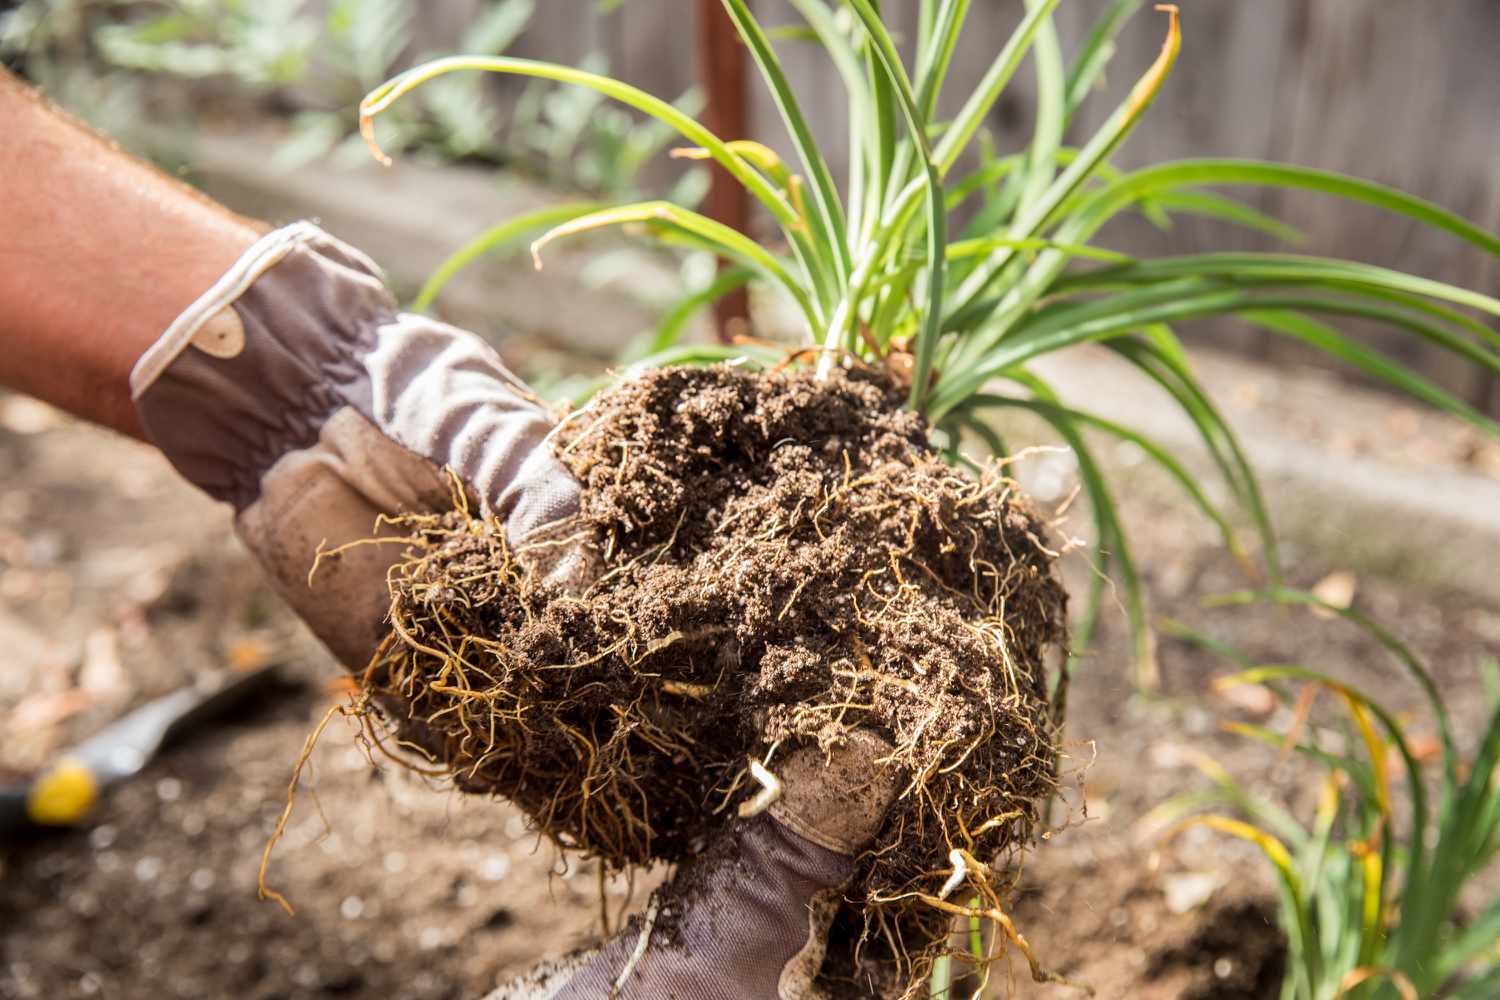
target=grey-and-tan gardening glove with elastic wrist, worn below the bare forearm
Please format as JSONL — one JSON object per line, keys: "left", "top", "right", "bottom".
{"left": 131, "top": 222, "right": 578, "bottom": 669}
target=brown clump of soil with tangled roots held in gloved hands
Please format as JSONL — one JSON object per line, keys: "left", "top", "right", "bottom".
{"left": 366, "top": 366, "right": 1065, "bottom": 982}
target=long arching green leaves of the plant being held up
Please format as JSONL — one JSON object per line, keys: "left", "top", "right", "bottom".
{"left": 362, "top": 0, "right": 1500, "bottom": 704}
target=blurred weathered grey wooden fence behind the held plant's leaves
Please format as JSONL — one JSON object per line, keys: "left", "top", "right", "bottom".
{"left": 426, "top": 0, "right": 1500, "bottom": 414}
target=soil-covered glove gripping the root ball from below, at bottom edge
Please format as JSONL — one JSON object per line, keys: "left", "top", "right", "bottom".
{"left": 486, "top": 730, "right": 900, "bottom": 1000}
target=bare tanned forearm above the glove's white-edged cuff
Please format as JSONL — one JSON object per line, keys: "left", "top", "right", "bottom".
{"left": 0, "top": 70, "right": 261, "bottom": 436}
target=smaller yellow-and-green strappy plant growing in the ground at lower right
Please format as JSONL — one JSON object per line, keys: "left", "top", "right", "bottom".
{"left": 1154, "top": 588, "right": 1500, "bottom": 1000}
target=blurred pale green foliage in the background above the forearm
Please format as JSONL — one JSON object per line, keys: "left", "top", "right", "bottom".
{"left": 0, "top": 0, "right": 707, "bottom": 202}
